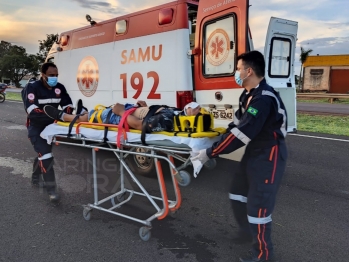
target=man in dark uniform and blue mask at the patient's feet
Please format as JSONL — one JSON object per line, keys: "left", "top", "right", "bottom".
{"left": 22, "top": 63, "right": 74, "bottom": 202}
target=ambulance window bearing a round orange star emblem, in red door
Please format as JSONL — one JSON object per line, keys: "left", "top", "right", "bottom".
{"left": 203, "top": 15, "right": 236, "bottom": 77}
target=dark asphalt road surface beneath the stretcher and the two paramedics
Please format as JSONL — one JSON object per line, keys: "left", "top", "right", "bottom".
{"left": 0, "top": 101, "right": 349, "bottom": 262}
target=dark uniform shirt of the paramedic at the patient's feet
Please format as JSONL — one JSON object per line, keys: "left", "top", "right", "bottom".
{"left": 22, "top": 78, "right": 73, "bottom": 128}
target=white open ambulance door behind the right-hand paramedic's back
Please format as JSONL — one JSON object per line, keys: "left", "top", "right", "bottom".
{"left": 264, "top": 17, "right": 298, "bottom": 132}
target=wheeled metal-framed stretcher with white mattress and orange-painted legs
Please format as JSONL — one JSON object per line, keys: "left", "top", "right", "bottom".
{"left": 41, "top": 122, "right": 223, "bottom": 241}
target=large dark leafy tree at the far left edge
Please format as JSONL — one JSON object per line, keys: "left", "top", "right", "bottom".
{"left": 0, "top": 44, "right": 39, "bottom": 87}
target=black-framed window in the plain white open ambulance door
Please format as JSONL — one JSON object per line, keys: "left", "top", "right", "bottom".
{"left": 268, "top": 37, "right": 291, "bottom": 78}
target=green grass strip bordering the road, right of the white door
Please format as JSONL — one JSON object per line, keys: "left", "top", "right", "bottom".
{"left": 297, "top": 114, "right": 349, "bottom": 136}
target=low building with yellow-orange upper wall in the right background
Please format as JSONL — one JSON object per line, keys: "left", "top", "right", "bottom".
{"left": 303, "top": 55, "right": 349, "bottom": 94}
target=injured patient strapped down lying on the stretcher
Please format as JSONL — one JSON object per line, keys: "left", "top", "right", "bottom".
{"left": 44, "top": 99, "right": 201, "bottom": 132}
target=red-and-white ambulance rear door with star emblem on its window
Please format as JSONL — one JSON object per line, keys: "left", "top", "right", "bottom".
{"left": 194, "top": 0, "right": 249, "bottom": 127}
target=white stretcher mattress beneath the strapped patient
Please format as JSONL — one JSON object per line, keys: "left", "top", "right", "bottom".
{"left": 41, "top": 123, "right": 219, "bottom": 152}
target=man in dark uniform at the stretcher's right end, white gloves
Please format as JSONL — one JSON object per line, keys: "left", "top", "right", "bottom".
{"left": 192, "top": 51, "right": 287, "bottom": 262}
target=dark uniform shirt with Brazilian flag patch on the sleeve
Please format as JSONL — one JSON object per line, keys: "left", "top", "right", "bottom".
{"left": 206, "top": 79, "right": 287, "bottom": 158}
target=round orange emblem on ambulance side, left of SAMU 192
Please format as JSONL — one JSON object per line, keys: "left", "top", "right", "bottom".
{"left": 76, "top": 56, "right": 99, "bottom": 97}
